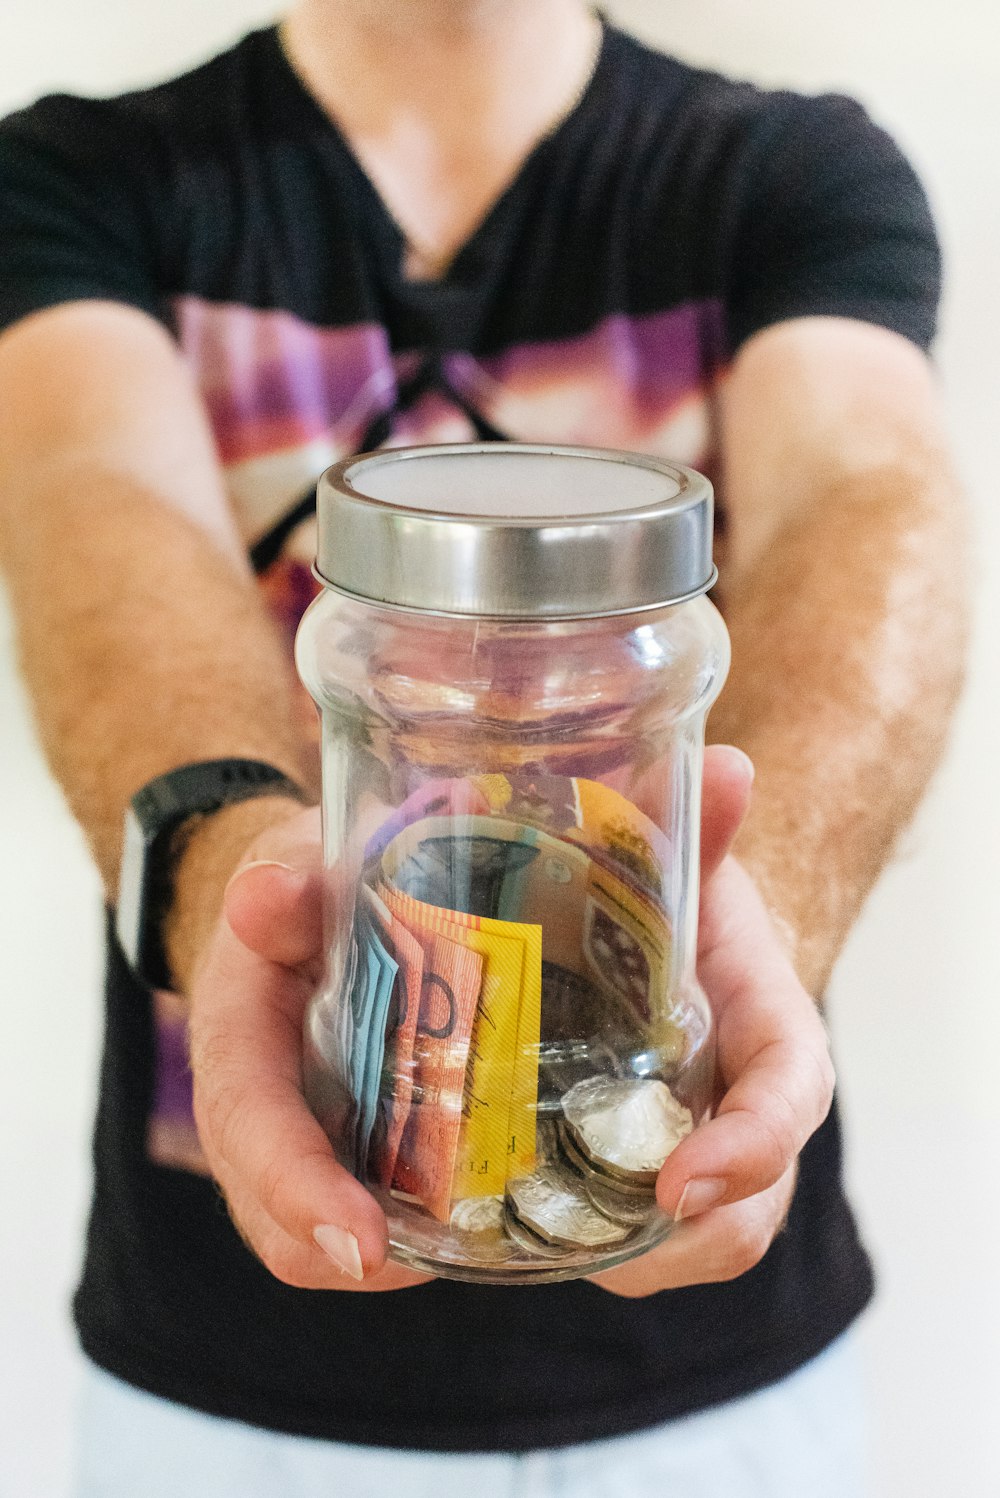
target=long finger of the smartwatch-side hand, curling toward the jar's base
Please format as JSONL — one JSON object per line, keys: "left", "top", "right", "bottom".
{"left": 190, "top": 927, "right": 388, "bottom": 1275}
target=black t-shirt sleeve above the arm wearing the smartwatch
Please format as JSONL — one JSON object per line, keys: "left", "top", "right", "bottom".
{"left": 0, "top": 96, "right": 162, "bottom": 338}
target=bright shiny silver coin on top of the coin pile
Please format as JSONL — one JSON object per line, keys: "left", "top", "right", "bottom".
{"left": 563, "top": 1077, "right": 693, "bottom": 1186}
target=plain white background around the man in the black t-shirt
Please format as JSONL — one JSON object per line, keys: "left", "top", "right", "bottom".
{"left": 0, "top": 0, "right": 1000, "bottom": 1498}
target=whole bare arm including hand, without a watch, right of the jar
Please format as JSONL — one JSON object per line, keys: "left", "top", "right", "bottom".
{"left": 599, "top": 319, "right": 967, "bottom": 1296}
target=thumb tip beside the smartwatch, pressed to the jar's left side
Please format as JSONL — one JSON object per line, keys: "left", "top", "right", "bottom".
{"left": 223, "top": 860, "right": 323, "bottom": 968}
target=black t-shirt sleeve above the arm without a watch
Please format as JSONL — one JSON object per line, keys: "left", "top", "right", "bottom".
{"left": 728, "top": 94, "right": 940, "bottom": 351}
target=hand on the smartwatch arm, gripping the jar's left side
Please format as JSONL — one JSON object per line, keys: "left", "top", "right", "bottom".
{"left": 190, "top": 807, "right": 428, "bottom": 1290}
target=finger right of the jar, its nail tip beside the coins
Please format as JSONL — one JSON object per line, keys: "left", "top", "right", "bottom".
{"left": 657, "top": 860, "right": 834, "bottom": 1216}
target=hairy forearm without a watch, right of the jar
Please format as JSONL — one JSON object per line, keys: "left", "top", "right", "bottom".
{"left": 710, "top": 454, "right": 969, "bottom": 995}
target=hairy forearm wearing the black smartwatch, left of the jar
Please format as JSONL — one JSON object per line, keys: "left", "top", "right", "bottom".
{"left": 1, "top": 463, "right": 316, "bottom": 982}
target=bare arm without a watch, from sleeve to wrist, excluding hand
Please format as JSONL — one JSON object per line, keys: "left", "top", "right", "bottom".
{"left": 710, "top": 318, "right": 969, "bottom": 993}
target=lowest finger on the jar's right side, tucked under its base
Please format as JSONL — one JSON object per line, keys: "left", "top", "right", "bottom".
{"left": 590, "top": 1165, "right": 798, "bottom": 1299}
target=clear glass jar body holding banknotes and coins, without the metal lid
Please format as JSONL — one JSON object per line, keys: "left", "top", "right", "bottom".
{"left": 296, "top": 589, "right": 729, "bottom": 1282}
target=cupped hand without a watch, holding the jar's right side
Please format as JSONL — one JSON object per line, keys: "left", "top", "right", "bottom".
{"left": 593, "top": 748, "right": 834, "bottom": 1296}
